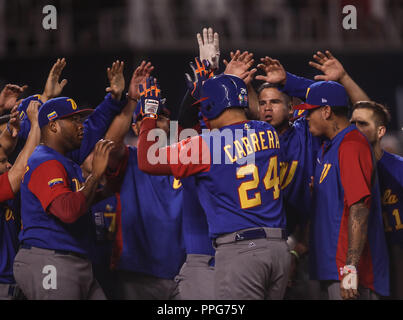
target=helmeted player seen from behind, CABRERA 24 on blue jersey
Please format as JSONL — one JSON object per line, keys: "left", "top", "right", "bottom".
{"left": 138, "top": 74, "right": 291, "bottom": 299}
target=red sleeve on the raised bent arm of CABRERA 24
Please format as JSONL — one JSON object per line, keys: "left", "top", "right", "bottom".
{"left": 137, "top": 119, "right": 211, "bottom": 178}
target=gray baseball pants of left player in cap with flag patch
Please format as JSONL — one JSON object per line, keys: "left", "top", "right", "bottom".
{"left": 14, "top": 247, "right": 106, "bottom": 300}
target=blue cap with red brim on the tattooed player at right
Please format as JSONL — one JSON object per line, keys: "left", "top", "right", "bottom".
{"left": 294, "top": 81, "right": 348, "bottom": 110}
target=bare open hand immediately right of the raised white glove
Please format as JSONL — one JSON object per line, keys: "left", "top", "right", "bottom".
{"left": 224, "top": 50, "right": 257, "bottom": 85}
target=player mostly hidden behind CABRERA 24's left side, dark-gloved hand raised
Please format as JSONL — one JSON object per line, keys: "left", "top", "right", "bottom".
{"left": 176, "top": 55, "right": 215, "bottom": 300}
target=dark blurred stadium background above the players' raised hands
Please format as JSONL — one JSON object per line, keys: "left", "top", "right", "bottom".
{"left": 0, "top": 0, "right": 403, "bottom": 149}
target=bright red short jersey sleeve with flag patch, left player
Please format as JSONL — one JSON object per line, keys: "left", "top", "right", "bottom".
{"left": 28, "top": 160, "right": 73, "bottom": 211}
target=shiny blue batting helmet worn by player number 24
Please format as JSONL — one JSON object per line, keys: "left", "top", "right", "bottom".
{"left": 201, "top": 74, "right": 248, "bottom": 120}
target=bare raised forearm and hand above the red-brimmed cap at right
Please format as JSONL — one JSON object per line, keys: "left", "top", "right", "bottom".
{"left": 309, "top": 50, "right": 370, "bottom": 104}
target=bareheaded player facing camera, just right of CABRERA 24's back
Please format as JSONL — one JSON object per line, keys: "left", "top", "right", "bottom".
{"left": 258, "top": 82, "right": 320, "bottom": 299}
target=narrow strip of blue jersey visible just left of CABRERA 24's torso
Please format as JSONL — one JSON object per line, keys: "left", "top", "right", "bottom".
{"left": 181, "top": 177, "right": 215, "bottom": 256}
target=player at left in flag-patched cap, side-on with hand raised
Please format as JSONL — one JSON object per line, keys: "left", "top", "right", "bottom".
{"left": 14, "top": 98, "right": 113, "bottom": 300}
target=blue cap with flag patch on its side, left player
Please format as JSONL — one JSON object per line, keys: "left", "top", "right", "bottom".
{"left": 38, "top": 97, "right": 93, "bottom": 128}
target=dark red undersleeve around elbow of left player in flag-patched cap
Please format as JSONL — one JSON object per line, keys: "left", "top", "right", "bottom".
{"left": 48, "top": 191, "right": 87, "bottom": 223}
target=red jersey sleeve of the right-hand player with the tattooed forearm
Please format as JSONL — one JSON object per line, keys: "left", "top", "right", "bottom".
{"left": 339, "top": 131, "right": 373, "bottom": 207}
